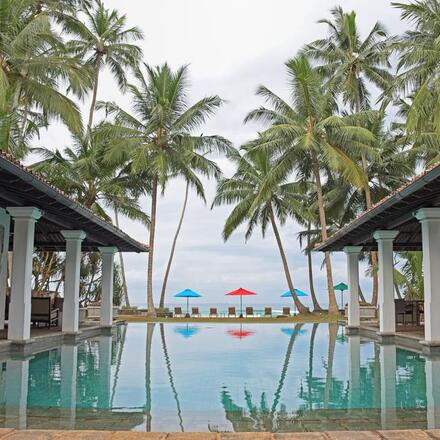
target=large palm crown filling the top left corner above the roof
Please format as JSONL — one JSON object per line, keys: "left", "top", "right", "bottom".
{"left": 0, "top": 0, "right": 89, "bottom": 158}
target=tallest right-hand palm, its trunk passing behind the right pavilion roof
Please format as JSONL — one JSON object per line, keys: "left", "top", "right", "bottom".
{"left": 305, "top": 6, "right": 393, "bottom": 304}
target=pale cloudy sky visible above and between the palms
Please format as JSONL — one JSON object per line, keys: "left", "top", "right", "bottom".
{"left": 39, "top": 0, "right": 406, "bottom": 305}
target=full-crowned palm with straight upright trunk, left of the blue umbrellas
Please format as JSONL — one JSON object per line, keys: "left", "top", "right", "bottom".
{"left": 98, "top": 64, "right": 230, "bottom": 316}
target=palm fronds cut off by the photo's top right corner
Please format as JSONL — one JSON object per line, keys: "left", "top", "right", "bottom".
{"left": 392, "top": 0, "right": 440, "bottom": 136}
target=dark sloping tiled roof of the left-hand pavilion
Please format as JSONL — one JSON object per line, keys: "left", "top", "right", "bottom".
{"left": 0, "top": 152, "right": 148, "bottom": 252}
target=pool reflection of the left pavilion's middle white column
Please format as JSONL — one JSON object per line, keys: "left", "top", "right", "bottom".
{"left": 60, "top": 344, "right": 78, "bottom": 429}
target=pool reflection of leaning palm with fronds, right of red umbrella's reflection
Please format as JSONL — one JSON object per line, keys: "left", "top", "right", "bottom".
{"left": 221, "top": 324, "right": 303, "bottom": 432}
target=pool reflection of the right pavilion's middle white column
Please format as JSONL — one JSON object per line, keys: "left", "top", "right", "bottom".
{"left": 380, "top": 345, "right": 397, "bottom": 429}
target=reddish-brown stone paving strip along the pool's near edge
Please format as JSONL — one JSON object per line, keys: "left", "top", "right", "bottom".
{"left": 0, "top": 429, "right": 440, "bottom": 440}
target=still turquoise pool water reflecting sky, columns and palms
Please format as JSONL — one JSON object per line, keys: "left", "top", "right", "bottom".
{"left": 0, "top": 323, "right": 440, "bottom": 432}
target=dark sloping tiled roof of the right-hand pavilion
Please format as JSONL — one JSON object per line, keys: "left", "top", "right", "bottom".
{"left": 315, "top": 162, "right": 440, "bottom": 251}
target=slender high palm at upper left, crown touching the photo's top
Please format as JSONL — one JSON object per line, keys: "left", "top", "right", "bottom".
{"left": 65, "top": 0, "right": 143, "bottom": 129}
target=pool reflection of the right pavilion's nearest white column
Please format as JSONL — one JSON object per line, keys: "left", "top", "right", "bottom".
{"left": 425, "top": 358, "right": 440, "bottom": 429}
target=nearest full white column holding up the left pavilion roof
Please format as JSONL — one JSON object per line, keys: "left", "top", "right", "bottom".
{"left": 8, "top": 207, "right": 41, "bottom": 341}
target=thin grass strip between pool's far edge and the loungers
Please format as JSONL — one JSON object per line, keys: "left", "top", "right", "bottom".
{"left": 118, "top": 313, "right": 343, "bottom": 324}
